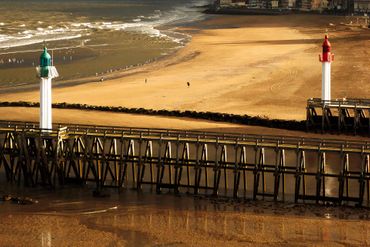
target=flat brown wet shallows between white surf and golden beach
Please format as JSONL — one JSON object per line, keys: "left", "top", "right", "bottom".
{"left": 0, "top": 31, "right": 182, "bottom": 89}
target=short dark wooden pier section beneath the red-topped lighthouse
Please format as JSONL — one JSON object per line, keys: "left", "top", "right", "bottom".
{"left": 306, "top": 98, "right": 370, "bottom": 135}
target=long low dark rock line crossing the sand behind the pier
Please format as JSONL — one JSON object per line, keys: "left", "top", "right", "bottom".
{"left": 0, "top": 101, "right": 306, "bottom": 130}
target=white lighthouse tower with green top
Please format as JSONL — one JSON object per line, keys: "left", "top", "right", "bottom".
{"left": 36, "top": 47, "right": 59, "bottom": 130}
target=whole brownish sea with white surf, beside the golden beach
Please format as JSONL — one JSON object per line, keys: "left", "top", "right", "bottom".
{"left": 0, "top": 0, "right": 211, "bottom": 91}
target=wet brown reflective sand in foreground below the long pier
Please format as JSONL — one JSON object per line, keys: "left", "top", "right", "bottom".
{"left": 0, "top": 188, "right": 370, "bottom": 246}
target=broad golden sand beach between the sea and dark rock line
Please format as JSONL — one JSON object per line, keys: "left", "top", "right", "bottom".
{"left": 1, "top": 15, "right": 370, "bottom": 120}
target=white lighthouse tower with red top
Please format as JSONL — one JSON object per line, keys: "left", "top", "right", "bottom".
{"left": 319, "top": 35, "right": 334, "bottom": 103}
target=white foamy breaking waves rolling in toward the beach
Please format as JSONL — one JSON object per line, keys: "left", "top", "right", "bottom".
{"left": 0, "top": 0, "right": 207, "bottom": 48}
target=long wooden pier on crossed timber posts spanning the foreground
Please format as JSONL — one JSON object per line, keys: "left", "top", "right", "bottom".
{"left": 0, "top": 122, "right": 370, "bottom": 206}
